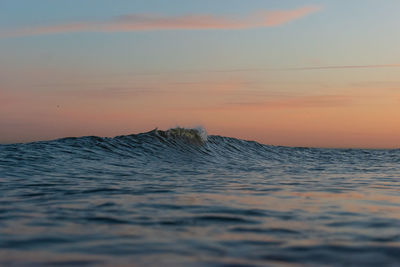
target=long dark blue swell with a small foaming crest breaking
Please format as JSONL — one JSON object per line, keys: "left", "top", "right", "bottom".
{"left": 0, "top": 127, "right": 398, "bottom": 164}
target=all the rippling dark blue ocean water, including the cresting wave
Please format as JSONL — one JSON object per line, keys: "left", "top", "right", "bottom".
{"left": 0, "top": 130, "right": 400, "bottom": 266}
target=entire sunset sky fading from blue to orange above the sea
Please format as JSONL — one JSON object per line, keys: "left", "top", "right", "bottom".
{"left": 0, "top": 0, "right": 400, "bottom": 148}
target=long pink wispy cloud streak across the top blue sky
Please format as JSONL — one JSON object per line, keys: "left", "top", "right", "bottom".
{"left": 0, "top": 6, "right": 322, "bottom": 37}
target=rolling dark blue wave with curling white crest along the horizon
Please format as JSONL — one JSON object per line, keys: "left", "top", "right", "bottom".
{"left": 0, "top": 127, "right": 400, "bottom": 171}
